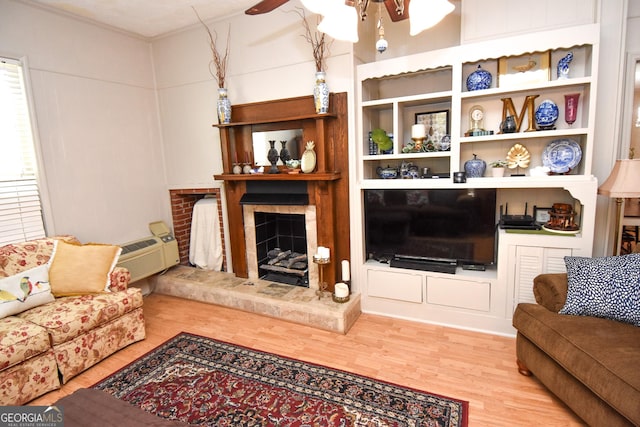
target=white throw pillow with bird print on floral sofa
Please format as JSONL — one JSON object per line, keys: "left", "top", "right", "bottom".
{"left": 0, "top": 264, "right": 54, "bottom": 318}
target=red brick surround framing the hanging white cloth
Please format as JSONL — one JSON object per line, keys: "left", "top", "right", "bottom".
{"left": 169, "top": 188, "right": 228, "bottom": 271}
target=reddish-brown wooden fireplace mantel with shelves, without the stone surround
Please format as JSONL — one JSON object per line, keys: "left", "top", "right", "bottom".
{"left": 214, "top": 93, "right": 350, "bottom": 289}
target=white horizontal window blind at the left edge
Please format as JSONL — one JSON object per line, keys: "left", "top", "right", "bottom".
{"left": 0, "top": 58, "right": 45, "bottom": 245}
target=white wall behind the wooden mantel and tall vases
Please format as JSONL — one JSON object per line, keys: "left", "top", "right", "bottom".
{"left": 152, "top": 0, "right": 353, "bottom": 188}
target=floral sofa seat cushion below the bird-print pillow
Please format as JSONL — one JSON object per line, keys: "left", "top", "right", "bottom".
{"left": 0, "top": 316, "right": 51, "bottom": 371}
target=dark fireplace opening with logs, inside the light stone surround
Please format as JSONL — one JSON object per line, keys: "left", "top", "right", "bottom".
{"left": 254, "top": 212, "right": 309, "bottom": 287}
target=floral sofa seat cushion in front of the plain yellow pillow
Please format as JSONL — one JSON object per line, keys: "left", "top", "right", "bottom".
{"left": 17, "top": 288, "right": 142, "bottom": 346}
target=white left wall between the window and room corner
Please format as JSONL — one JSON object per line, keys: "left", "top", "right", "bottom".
{"left": 0, "top": 0, "right": 171, "bottom": 243}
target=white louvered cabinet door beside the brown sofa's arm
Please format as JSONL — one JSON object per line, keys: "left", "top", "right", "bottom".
{"left": 514, "top": 246, "right": 571, "bottom": 309}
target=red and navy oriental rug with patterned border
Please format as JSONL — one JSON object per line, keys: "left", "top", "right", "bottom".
{"left": 93, "top": 333, "right": 468, "bottom": 427}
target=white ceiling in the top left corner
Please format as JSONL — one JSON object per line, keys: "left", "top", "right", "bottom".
{"left": 25, "top": 0, "right": 260, "bottom": 38}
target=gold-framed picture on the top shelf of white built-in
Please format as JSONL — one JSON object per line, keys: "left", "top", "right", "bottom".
{"left": 498, "top": 51, "right": 551, "bottom": 88}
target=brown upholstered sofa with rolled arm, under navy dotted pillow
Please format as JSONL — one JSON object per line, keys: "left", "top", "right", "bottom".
{"left": 513, "top": 274, "right": 640, "bottom": 427}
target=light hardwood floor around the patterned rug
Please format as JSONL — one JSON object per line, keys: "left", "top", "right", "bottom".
{"left": 31, "top": 294, "right": 584, "bottom": 427}
